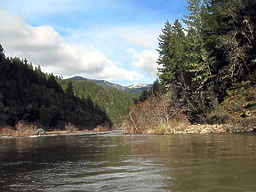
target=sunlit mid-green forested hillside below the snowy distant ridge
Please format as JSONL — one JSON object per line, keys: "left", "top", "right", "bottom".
{"left": 59, "top": 79, "right": 138, "bottom": 123}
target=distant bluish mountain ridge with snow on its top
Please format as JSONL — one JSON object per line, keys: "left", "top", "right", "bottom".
{"left": 67, "top": 76, "right": 153, "bottom": 93}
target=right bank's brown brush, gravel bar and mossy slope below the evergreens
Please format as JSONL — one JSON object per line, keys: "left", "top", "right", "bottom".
{"left": 122, "top": 82, "right": 256, "bottom": 135}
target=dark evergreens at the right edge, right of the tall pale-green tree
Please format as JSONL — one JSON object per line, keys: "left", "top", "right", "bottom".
{"left": 203, "top": 0, "right": 256, "bottom": 99}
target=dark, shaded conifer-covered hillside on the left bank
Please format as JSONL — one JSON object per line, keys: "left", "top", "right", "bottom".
{"left": 0, "top": 46, "right": 112, "bottom": 129}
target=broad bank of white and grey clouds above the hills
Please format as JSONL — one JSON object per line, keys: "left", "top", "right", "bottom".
{"left": 0, "top": 11, "right": 162, "bottom": 84}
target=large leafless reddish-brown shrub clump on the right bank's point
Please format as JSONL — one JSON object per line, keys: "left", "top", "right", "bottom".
{"left": 122, "top": 96, "right": 189, "bottom": 134}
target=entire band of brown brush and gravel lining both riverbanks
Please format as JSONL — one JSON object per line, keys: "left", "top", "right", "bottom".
{"left": 0, "top": 82, "right": 256, "bottom": 137}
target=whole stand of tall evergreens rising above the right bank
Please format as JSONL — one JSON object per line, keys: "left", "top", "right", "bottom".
{"left": 158, "top": 0, "right": 256, "bottom": 121}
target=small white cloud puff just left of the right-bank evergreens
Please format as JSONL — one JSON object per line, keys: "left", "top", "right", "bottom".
{"left": 127, "top": 48, "right": 158, "bottom": 77}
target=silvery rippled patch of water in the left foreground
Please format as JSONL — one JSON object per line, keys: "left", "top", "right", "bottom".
{"left": 5, "top": 158, "right": 172, "bottom": 192}
